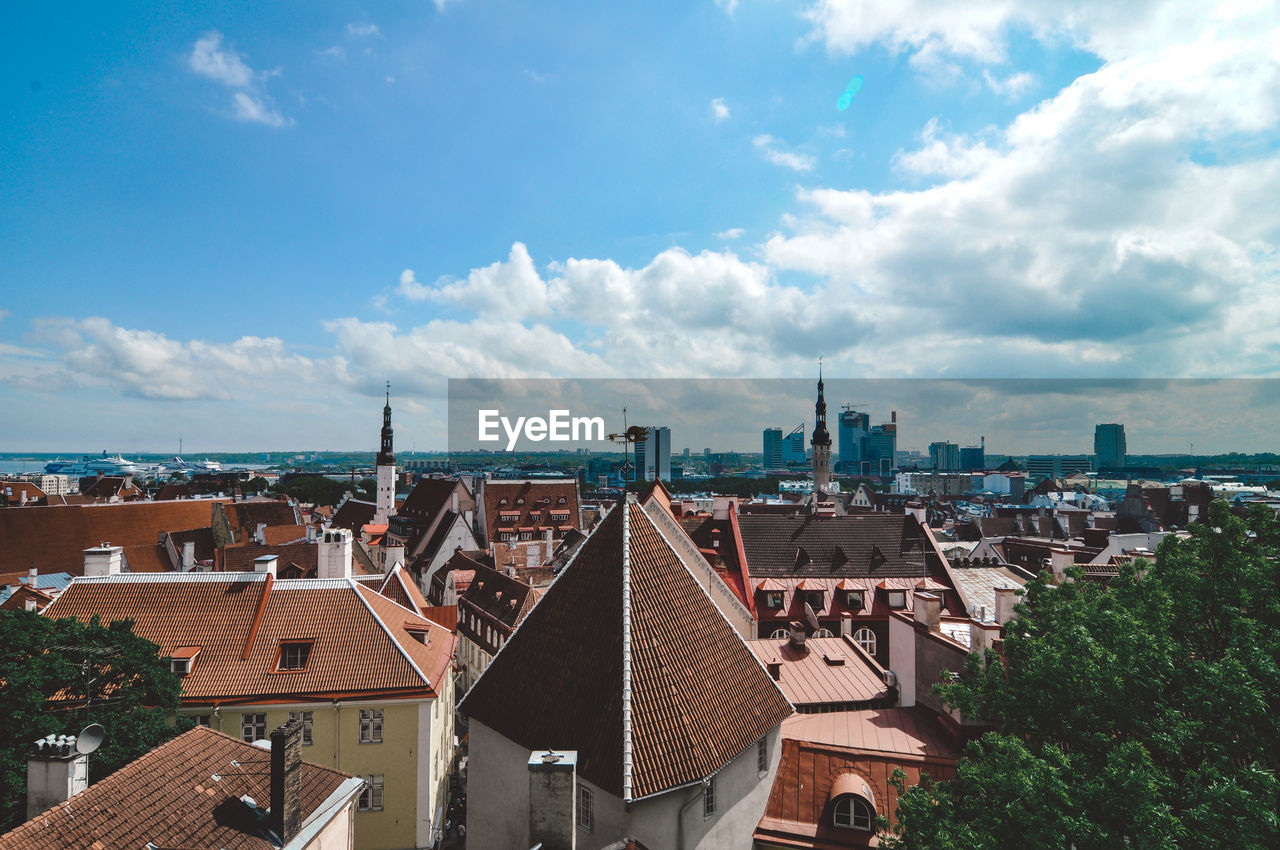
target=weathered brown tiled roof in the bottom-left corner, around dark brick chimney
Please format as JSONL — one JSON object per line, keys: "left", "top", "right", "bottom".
{"left": 0, "top": 726, "right": 352, "bottom": 850}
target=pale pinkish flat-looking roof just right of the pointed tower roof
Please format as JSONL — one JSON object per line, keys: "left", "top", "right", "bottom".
{"left": 746, "top": 638, "right": 897, "bottom": 712}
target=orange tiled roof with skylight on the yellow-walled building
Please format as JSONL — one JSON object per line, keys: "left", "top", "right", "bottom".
{"left": 45, "top": 572, "right": 454, "bottom": 704}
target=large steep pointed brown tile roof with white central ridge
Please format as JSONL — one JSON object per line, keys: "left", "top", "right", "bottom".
{"left": 462, "top": 498, "right": 791, "bottom": 800}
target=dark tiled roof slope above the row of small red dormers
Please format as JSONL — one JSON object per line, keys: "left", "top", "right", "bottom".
{"left": 737, "top": 513, "right": 943, "bottom": 579}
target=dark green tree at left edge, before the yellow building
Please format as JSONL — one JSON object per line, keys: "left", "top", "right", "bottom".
{"left": 0, "top": 611, "right": 192, "bottom": 830}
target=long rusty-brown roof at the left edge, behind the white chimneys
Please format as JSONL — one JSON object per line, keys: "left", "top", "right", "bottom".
{"left": 0, "top": 499, "right": 225, "bottom": 576}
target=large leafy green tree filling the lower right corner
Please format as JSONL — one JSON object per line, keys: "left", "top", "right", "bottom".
{"left": 884, "top": 502, "right": 1280, "bottom": 850}
